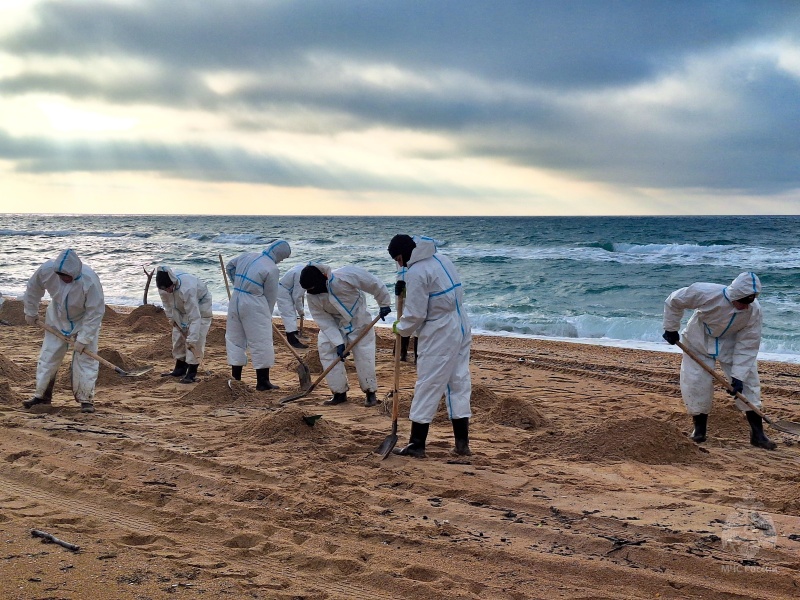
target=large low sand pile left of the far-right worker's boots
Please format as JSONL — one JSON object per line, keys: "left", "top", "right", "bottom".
{"left": 556, "top": 417, "right": 705, "bottom": 465}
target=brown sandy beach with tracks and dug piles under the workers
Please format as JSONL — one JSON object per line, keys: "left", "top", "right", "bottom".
{"left": 0, "top": 300, "right": 800, "bottom": 600}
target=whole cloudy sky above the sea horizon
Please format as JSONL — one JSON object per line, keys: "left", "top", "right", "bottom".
{"left": 0, "top": 0, "right": 800, "bottom": 216}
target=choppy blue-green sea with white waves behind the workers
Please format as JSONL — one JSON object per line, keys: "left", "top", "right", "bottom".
{"left": 0, "top": 214, "right": 800, "bottom": 362}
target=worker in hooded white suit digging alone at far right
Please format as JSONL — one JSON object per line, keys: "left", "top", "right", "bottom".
{"left": 663, "top": 273, "right": 776, "bottom": 450}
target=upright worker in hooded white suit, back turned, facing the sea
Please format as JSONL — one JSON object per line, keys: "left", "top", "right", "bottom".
{"left": 225, "top": 240, "right": 292, "bottom": 391}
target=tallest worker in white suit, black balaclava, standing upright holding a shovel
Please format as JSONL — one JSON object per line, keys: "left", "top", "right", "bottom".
{"left": 388, "top": 234, "right": 472, "bottom": 458}
